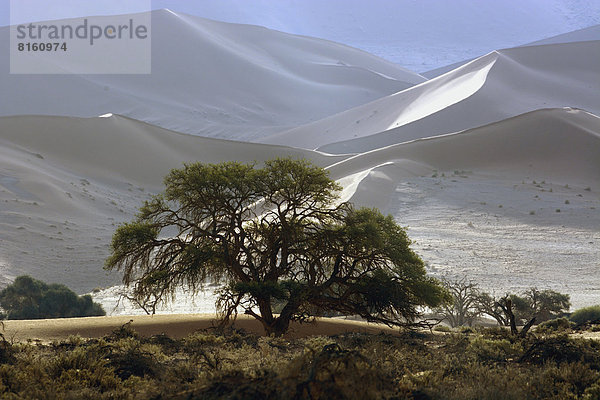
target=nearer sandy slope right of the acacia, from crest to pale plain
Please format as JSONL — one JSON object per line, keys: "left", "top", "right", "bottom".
{"left": 330, "top": 109, "right": 600, "bottom": 308}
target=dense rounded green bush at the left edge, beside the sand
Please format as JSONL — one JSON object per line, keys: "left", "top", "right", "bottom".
{"left": 0, "top": 275, "right": 106, "bottom": 319}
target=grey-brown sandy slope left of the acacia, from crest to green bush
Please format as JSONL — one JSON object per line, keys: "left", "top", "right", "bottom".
{"left": 0, "top": 116, "right": 340, "bottom": 292}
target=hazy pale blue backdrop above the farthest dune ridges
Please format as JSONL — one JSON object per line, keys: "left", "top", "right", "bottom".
{"left": 0, "top": 0, "right": 600, "bottom": 71}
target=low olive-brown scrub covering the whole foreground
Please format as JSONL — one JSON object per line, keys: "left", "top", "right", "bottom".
{"left": 0, "top": 326, "right": 600, "bottom": 400}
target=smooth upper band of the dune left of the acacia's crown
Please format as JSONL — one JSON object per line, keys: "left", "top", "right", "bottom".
{"left": 0, "top": 115, "right": 344, "bottom": 190}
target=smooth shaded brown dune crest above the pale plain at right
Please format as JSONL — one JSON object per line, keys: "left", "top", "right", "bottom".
{"left": 328, "top": 108, "right": 600, "bottom": 183}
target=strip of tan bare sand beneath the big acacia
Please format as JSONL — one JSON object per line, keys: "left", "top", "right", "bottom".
{"left": 3, "top": 314, "right": 398, "bottom": 343}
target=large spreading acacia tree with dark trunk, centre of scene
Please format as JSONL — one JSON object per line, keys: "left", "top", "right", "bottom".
{"left": 106, "top": 159, "right": 447, "bottom": 335}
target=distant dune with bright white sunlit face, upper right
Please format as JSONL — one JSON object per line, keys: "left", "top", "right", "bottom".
{"left": 263, "top": 41, "right": 600, "bottom": 153}
